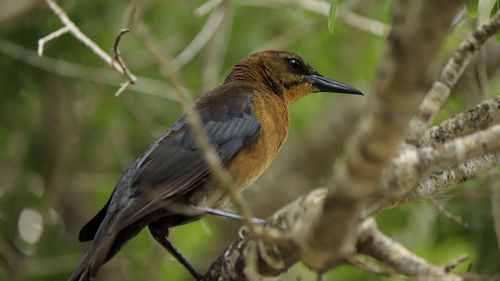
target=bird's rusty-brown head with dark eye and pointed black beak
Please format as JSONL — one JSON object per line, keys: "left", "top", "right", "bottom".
{"left": 224, "top": 51, "right": 363, "bottom": 104}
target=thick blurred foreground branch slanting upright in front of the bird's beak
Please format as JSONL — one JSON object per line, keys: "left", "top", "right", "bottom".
{"left": 294, "top": 0, "right": 461, "bottom": 270}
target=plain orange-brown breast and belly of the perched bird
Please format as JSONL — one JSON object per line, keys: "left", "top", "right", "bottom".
{"left": 226, "top": 91, "right": 289, "bottom": 191}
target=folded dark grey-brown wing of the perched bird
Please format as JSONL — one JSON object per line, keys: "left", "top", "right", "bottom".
{"left": 80, "top": 86, "right": 260, "bottom": 241}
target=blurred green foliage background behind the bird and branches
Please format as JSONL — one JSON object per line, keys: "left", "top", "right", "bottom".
{"left": 0, "top": 0, "right": 500, "bottom": 281}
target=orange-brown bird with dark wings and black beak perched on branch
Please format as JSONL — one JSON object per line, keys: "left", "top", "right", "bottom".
{"left": 69, "top": 50, "right": 363, "bottom": 281}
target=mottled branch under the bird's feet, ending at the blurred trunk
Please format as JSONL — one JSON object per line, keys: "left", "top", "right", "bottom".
{"left": 203, "top": 189, "right": 326, "bottom": 281}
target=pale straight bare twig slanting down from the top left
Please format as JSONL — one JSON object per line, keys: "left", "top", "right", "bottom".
{"left": 44, "top": 0, "right": 137, "bottom": 80}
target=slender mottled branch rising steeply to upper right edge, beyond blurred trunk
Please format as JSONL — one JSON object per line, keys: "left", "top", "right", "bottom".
{"left": 406, "top": 14, "right": 500, "bottom": 143}
